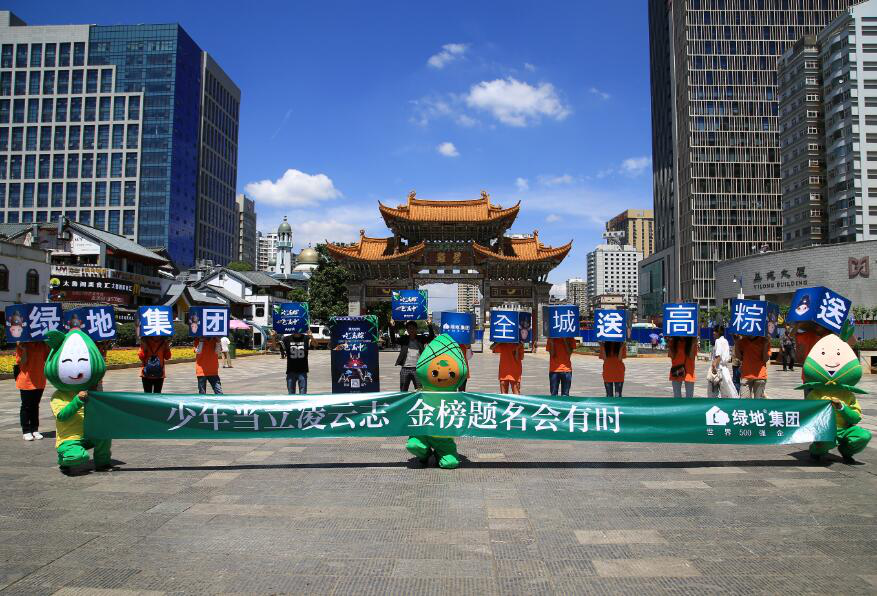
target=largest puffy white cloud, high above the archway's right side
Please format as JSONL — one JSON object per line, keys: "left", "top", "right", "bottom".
{"left": 465, "top": 77, "right": 570, "bottom": 126}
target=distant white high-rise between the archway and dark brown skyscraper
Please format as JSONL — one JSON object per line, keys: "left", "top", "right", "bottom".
{"left": 587, "top": 244, "right": 643, "bottom": 310}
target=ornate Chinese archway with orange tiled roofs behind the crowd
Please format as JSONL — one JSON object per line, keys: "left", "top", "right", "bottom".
{"left": 327, "top": 191, "right": 572, "bottom": 338}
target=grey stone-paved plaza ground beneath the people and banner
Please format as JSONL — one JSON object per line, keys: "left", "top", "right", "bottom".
{"left": 0, "top": 352, "right": 877, "bottom": 595}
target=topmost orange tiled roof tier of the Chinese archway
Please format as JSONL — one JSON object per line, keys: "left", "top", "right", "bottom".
{"left": 378, "top": 192, "right": 521, "bottom": 223}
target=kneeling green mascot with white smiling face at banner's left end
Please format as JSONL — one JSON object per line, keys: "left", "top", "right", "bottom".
{"left": 46, "top": 329, "right": 112, "bottom": 474}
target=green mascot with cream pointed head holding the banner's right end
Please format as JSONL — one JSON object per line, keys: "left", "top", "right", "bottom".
{"left": 797, "top": 335, "right": 871, "bottom": 461}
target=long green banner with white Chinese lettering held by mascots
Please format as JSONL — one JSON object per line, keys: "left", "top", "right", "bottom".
{"left": 85, "top": 391, "right": 836, "bottom": 445}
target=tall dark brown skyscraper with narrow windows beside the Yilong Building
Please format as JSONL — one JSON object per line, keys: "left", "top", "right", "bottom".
{"left": 644, "top": 0, "right": 850, "bottom": 306}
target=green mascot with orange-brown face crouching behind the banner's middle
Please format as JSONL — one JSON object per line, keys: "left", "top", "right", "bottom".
{"left": 406, "top": 334, "right": 468, "bottom": 470}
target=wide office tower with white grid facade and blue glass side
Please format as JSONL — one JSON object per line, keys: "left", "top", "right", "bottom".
{"left": 0, "top": 11, "right": 240, "bottom": 267}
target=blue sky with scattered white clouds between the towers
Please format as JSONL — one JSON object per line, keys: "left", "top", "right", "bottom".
{"left": 8, "top": 0, "right": 652, "bottom": 308}
